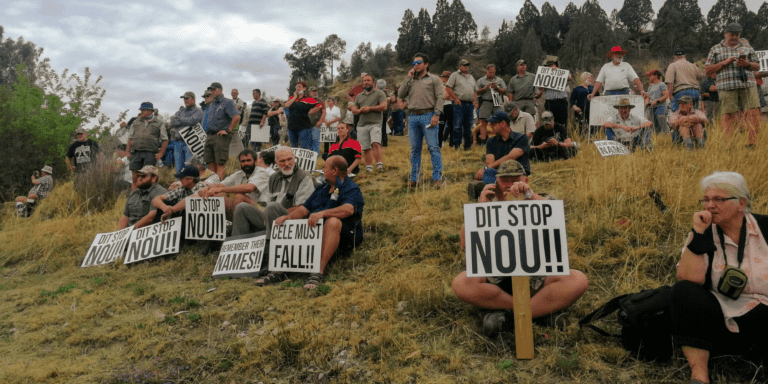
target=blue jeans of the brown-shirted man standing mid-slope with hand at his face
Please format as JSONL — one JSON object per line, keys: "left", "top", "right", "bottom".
{"left": 408, "top": 112, "right": 443, "bottom": 183}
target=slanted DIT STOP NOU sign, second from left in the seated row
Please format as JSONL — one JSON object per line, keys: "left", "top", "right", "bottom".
{"left": 123, "top": 217, "right": 181, "bottom": 264}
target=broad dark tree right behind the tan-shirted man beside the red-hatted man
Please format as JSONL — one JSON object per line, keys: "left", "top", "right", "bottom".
{"left": 650, "top": 0, "right": 710, "bottom": 57}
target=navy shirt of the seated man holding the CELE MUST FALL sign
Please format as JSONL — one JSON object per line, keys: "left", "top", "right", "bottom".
{"left": 304, "top": 178, "right": 365, "bottom": 244}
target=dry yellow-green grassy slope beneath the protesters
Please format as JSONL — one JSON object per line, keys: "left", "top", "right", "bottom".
{"left": 0, "top": 124, "right": 768, "bottom": 383}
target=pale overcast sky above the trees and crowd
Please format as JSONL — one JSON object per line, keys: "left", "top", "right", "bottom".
{"left": 0, "top": 0, "right": 732, "bottom": 127}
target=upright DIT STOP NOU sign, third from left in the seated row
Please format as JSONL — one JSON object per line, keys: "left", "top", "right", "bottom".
{"left": 184, "top": 196, "right": 227, "bottom": 241}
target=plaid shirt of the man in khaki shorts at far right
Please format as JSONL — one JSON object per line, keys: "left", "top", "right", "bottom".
{"left": 704, "top": 39, "right": 757, "bottom": 91}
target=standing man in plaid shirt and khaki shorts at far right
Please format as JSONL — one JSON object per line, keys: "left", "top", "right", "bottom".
{"left": 704, "top": 23, "right": 760, "bottom": 147}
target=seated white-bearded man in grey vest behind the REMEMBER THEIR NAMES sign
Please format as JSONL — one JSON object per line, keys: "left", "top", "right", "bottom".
{"left": 232, "top": 147, "right": 315, "bottom": 236}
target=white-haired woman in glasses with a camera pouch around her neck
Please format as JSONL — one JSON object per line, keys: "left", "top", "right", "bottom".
{"left": 671, "top": 172, "right": 768, "bottom": 383}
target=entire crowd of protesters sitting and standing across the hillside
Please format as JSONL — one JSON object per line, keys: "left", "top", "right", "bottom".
{"left": 10, "top": 23, "right": 768, "bottom": 382}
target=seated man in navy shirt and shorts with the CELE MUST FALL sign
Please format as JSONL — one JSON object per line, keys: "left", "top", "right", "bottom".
{"left": 275, "top": 156, "right": 365, "bottom": 289}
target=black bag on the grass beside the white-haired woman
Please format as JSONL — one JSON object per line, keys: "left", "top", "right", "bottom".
{"left": 579, "top": 286, "right": 674, "bottom": 362}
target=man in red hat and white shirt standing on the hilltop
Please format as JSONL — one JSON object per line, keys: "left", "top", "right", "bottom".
{"left": 587, "top": 45, "right": 645, "bottom": 100}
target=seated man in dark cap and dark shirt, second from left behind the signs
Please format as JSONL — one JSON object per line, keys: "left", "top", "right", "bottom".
{"left": 134, "top": 165, "right": 207, "bottom": 229}
